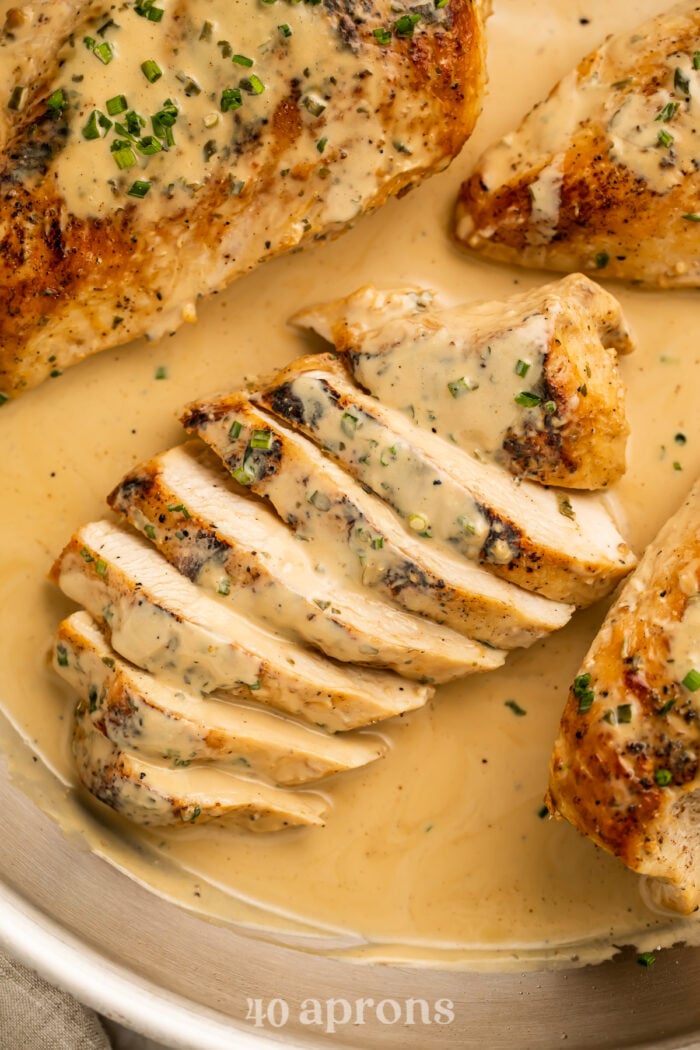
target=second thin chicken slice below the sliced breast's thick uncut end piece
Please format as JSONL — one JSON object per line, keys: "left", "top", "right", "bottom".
{"left": 183, "top": 394, "right": 573, "bottom": 649}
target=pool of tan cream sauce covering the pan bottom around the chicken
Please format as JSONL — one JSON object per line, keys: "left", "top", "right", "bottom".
{"left": 0, "top": 0, "right": 700, "bottom": 969}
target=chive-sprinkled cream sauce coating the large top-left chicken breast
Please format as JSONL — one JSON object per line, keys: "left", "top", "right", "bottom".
{"left": 21, "top": 0, "right": 442, "bottom": 221}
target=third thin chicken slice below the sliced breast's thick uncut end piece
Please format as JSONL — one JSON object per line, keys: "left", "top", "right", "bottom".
{"left": 108, "top": 442, "right": 497, "bottom": 683}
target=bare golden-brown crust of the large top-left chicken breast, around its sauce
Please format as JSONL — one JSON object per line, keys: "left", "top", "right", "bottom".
{"left": 0, "top": 0, "right": 484, "bottom": 398}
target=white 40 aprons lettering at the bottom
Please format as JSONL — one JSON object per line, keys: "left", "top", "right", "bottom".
{"left": 246, "top": 999, "right": 454, "bottom": 1035}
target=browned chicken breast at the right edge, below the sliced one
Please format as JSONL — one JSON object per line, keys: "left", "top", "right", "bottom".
{"left": 548, "top": 481, "right": 700, "bottom": 912}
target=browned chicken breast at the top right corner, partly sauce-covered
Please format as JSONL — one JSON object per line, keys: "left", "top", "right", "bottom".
{"left": 455, "top": 0, "right": 700, "bottom": 288}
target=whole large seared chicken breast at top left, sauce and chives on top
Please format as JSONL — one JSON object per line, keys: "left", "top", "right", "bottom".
{"left": 0, "top": 0, "right": 485, "bottom": 401}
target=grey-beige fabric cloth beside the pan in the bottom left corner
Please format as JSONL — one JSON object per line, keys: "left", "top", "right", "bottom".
{"left": 0, "top": 952, "right": 167, "bottom": 1050}
